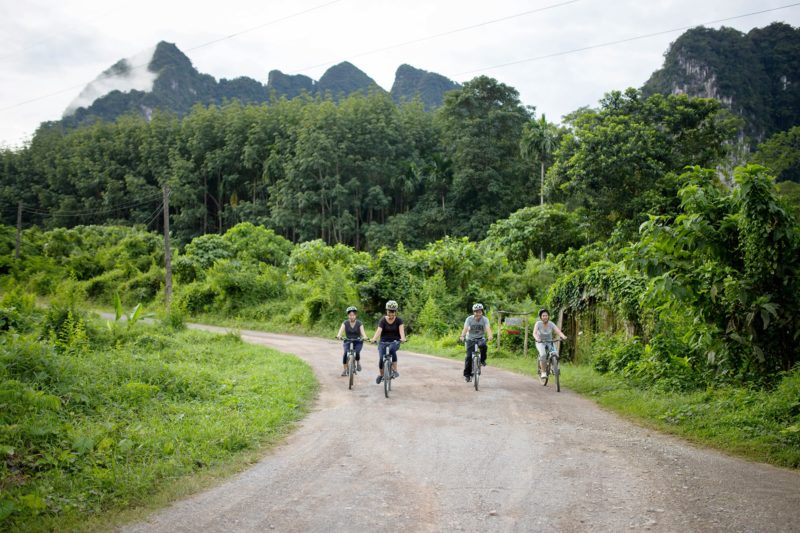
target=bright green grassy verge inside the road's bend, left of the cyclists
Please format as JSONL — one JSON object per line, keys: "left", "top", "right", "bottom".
{"left": 0, "top": 323, "right": 317, "bottom": 531}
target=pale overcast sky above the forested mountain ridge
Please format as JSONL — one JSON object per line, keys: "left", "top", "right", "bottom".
{"left": 0, "top": 0, "right": 800, "bottom": 146}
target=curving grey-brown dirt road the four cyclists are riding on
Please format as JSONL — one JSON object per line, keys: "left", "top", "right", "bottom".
{"left": 124, "top": 328, "right": 800, "bottom": 532}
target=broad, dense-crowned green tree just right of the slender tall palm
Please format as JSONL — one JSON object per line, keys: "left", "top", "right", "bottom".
{"left": 548, "top": 89, "right": 738, "bottom": 239}
